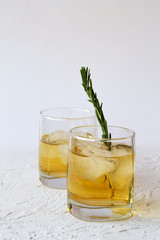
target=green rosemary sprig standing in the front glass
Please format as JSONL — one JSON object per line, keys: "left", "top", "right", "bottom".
{"left": 80, "top": 67, "right": 111, "bottom": 150}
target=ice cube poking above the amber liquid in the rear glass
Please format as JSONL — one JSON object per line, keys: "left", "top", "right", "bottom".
{"left": 49, "top": 130, "right": 68, "bottom": 145}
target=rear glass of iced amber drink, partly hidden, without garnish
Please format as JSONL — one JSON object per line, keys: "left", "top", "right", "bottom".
{"left": 39, "top": 108, "right": 96, "bottom": 189}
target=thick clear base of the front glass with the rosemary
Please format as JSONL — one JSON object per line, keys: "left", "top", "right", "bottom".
{"left": 67, "top": 200, "right": 132, "bottom": 222}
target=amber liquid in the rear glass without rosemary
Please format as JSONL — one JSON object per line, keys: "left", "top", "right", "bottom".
{"left": 39, "top": 136, "right": 68, "bottom": 177}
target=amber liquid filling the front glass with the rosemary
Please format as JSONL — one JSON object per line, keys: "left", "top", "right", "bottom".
{"left": 68, "top": 145, "right": 134, "bottom": 206}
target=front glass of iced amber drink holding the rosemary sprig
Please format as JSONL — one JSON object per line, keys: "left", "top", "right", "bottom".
{"left": 67, "top": 125, "right": 135, "bottom": 221}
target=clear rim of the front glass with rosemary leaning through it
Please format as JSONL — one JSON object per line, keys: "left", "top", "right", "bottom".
{"left": 69, "top": 125, "right": 135, "bottom": 142}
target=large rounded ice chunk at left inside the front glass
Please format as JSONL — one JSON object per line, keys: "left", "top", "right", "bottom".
{"left": 73, "top": 143, "right": 119, "bottom": 181}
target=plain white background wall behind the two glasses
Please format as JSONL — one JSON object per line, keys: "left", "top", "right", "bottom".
{"left": 0, "top": 0, "right": 160, "bottom": 149}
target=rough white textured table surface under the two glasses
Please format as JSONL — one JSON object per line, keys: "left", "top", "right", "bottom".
{"left": 0, "top": 147, "right": 160, "bottom": 240}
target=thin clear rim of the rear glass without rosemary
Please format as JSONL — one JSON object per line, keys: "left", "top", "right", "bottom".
{"left": 40, "top": 107, "right": 95, "bottom": 120}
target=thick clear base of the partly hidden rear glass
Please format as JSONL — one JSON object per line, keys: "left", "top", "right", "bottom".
{"left": 39, "top": 172, "right": 67, "bottom": 189}
